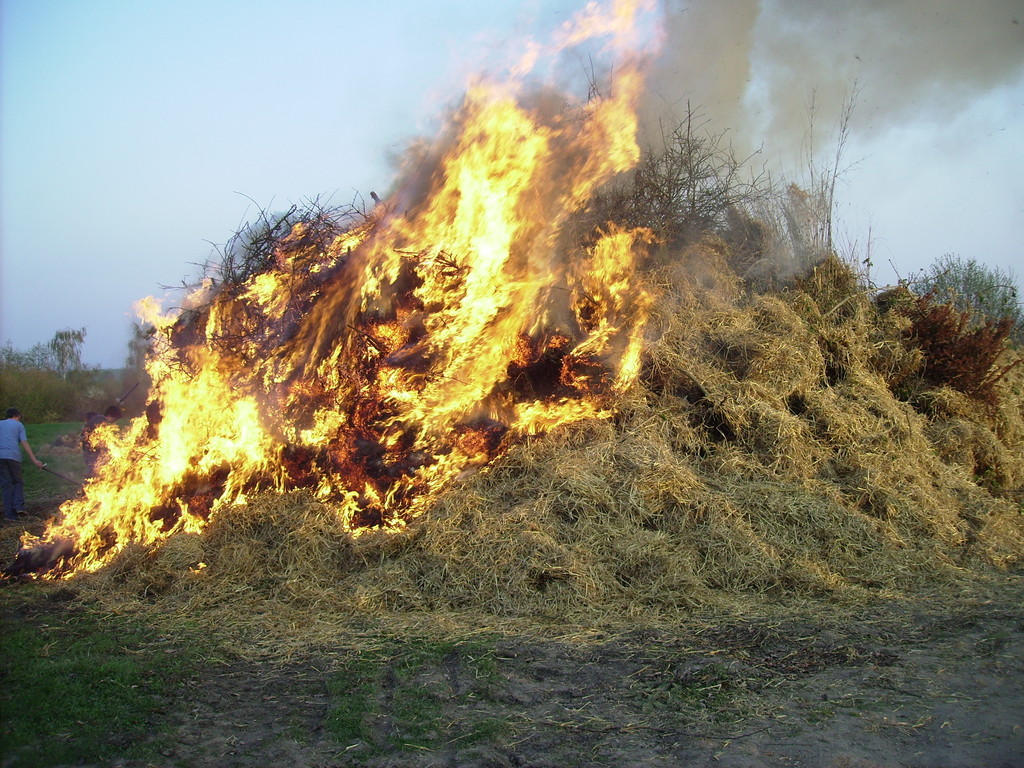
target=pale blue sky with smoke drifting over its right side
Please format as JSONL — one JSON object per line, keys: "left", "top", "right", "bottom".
{"left": 0, "top": 0, "right": 1024, "bottom": 368}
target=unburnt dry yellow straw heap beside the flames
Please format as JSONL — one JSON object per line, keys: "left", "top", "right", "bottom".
{"left": 88, "top": 242, "right": 1024, "bottom": 632}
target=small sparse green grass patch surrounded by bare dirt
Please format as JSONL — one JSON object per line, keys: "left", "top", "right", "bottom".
{"left": 327, "top": 640, "right": 505, "bottom": 759}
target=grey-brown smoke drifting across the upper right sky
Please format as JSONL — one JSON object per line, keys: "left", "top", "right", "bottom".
{"left": 643, "top": 0, "right": 1024, "bottom": 169}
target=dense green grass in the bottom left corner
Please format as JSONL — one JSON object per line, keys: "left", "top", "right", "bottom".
{"left": 0, "top": 585, "right": 211, "bottom": 768}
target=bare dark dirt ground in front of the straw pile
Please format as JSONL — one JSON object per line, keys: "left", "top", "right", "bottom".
{"left": 121, "top": 580, "right": 1024, "bottom": 768}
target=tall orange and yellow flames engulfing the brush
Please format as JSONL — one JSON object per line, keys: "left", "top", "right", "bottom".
{"left": 14, "top": 2, "right": 649, "bottom": 575}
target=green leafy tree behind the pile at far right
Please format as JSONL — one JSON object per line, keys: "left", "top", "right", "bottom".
{"left": 910, "top": 254, "right": 1024, "bottom": 344}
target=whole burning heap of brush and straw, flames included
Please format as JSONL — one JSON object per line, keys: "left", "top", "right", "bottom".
{"left": 8, "top": 3, "right": 1024, "bottom": 615}
